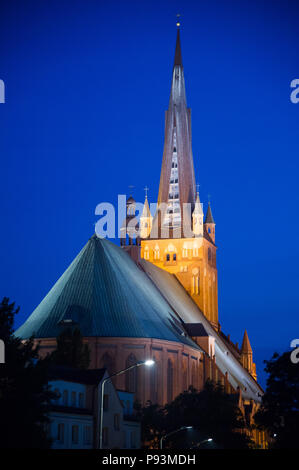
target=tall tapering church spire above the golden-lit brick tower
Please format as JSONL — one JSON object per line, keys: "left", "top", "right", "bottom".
{"left": 154, "top": 28, "right": 196, "bottom": 238}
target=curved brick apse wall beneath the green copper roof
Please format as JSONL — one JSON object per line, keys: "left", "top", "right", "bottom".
{"left": 39, "top": 338, "right": 233, "bottom": 405}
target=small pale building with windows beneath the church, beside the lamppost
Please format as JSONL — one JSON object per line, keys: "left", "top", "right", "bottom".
{"left": 48, "top": 366, "right": 140, "bottom": 449}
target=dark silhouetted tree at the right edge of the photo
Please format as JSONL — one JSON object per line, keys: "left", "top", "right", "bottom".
{"left": 255, "top": 352, "right": 299, "bottom": 449}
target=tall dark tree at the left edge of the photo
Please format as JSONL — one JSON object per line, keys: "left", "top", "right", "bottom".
{"left": 0, "top": 297, "right": 54, "bottom": 448}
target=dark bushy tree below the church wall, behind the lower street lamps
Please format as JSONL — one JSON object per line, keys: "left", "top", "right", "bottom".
{"left": 141, "top": 381, "right": 252, "bottom": 449}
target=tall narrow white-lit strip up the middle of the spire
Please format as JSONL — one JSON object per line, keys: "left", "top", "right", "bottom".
{"left": 164, "top": 128, "right": 181, "bottom": 227}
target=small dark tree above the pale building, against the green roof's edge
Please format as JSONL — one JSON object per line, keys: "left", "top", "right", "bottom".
{"left": 50, "top": 328, "right": 90, "bottom": 369}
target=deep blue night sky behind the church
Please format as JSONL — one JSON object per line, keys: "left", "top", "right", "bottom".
{"left": 0, "top": 0, "right": 299, "bottom": 386}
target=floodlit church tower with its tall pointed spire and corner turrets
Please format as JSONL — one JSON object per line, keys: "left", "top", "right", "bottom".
{"left": 140, "top": 28, "right": 219, "bottom": 330}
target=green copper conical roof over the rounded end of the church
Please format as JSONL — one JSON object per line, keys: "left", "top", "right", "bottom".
{"left": 15, "top": 236, "right": 196, "bottom": 347}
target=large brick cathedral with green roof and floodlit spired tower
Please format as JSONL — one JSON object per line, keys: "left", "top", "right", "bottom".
{"left": 16, "top": 25, "right": 265, "bottom": 446}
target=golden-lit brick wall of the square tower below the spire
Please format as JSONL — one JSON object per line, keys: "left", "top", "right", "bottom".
{"left": 140, "top": 237, "right": 218, "bottom": 329}
